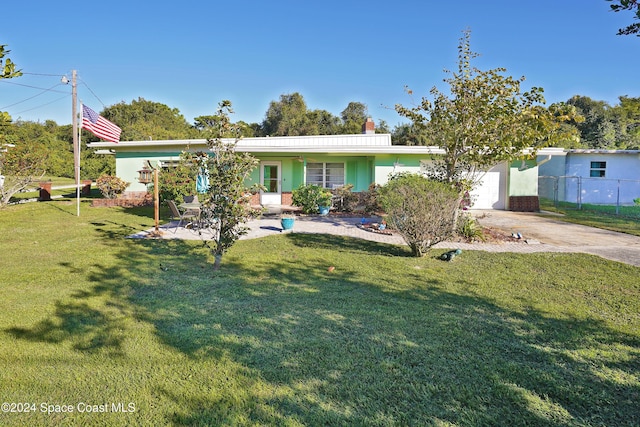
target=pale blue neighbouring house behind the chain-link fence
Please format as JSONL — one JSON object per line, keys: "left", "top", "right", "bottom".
{"left": 538, "top": 149, "right": 640, "bottom": 205}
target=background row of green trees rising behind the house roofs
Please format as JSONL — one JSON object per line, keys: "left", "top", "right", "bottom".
{"left": 0, "top": 93, "right": 640, "bottom": 182}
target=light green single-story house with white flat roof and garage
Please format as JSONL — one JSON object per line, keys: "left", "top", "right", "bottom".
{"left": 90, "top": 123, "right": 556, "bottom": 210}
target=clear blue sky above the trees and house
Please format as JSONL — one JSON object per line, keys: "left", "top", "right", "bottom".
{"left": 0, "top": 0, "right": 640, "bottom": 127}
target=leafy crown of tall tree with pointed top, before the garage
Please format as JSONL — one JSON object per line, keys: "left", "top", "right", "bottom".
{"left": 395, "top": 30, "right": 577, "bottom": 186}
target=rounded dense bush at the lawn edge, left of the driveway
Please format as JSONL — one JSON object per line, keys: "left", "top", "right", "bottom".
{"left": 378, "top": 174, "right": 459, "bottom": 257}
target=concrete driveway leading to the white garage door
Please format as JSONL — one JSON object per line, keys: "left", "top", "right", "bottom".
{"left": 473, "top": 210, "right": 640, "bottom": 267}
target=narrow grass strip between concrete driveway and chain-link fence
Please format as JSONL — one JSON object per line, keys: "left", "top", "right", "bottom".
{"left": 540, "top": 199, "right": 640, "bottom": 236}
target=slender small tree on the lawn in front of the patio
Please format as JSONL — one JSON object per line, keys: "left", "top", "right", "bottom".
{"left": 198, "top": 101, "right": 259, "bottom": 270}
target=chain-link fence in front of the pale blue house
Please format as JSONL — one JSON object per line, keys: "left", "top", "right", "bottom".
{"left": 538, "top": 176, "right": 640, "bottom": 217}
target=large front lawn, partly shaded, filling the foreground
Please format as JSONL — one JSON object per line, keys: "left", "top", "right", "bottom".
{"left": 0, "top": 201, "right": 640, "bottom": 426}
